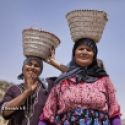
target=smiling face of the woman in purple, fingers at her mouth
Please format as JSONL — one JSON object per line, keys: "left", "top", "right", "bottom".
{"left": 23, "top": 60, "right": 41, "bottom": 79}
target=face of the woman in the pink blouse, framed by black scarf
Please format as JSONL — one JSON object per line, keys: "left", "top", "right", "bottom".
{"left": 75, "top": 45, "right": 94, "bottom": 67}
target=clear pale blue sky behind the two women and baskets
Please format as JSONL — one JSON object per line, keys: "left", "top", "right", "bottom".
{"left": 0, "top": 0, "right": 125, "bottom": 117}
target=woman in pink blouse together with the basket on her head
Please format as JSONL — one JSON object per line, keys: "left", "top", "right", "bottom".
{"left": 39, "top": 10, "right": 121, "bottom": 125}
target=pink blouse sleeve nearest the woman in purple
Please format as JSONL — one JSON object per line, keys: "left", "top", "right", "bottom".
{"left": 40, "top": 87, "right": 58, "bottom": 122}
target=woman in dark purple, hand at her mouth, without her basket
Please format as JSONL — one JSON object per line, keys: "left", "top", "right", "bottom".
{"left": 0, "top": 56, "right": 55, "bottom": 125}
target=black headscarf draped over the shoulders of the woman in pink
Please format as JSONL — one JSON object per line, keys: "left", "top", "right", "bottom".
{"left": 55, "top": 38, "right": 108, "bottom": 83}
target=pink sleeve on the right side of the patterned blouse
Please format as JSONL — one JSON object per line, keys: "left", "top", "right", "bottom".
{"left": 106, "top": 77, "right": 121, "bottom": 118}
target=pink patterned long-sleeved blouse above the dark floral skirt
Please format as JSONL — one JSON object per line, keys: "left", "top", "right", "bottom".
{"left": 40, "top": 77, "right": 120, "bottom": 121}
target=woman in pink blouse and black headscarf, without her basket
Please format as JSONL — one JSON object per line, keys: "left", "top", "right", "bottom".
{"left": 39, "top": 38, "right": 121, "bottom": 125}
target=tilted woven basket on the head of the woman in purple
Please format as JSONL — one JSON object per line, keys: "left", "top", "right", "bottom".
{"left": 22, "top": 28, "right": 60, "bottom": 59}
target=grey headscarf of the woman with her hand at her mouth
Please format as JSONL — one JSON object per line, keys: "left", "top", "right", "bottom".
{"left": 17, "top": 56, "right": 43, "bottom": 79}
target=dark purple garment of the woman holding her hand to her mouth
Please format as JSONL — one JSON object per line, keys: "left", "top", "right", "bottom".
{"left": 0, "top": 79, "right": 54, "bottom": 125}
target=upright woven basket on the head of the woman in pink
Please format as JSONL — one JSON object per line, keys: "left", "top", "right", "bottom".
{"left": 66, "top": 10, "right": 108, "bottom": 42}
